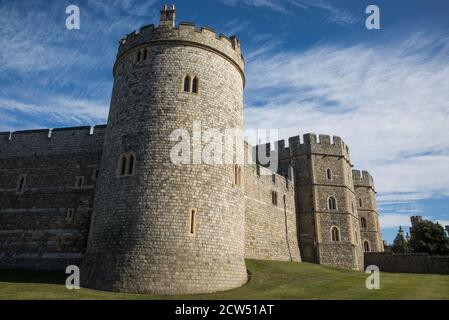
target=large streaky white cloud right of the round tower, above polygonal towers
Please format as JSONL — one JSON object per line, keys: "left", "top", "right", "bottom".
{"left": 245, "top": 34, "right": 449, "bottom": 201}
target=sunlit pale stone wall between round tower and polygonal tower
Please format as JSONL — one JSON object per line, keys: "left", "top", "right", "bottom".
{"left": 244, "top": 164, "right": 301, "bottom": 261}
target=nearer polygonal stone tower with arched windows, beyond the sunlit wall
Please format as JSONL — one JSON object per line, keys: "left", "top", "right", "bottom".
{"left": 258, "top": 133, "right": 363, "bottom": 270}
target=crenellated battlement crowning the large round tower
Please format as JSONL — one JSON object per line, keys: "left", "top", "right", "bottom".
{"left": 114, "top": 7, "right": 244, "bottom": 77}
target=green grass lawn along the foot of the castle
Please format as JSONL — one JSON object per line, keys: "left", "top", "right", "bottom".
{"left": 0, "top": 260, "right": 449, "bottom": 300}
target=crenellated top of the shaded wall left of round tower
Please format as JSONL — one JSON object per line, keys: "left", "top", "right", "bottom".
{"left": 0, "top": 125, "right": 106, "bottom": 158}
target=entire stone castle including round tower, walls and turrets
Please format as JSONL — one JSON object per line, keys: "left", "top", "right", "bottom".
{"left": 0, "top": 6, "right": 383, "bottom": 288}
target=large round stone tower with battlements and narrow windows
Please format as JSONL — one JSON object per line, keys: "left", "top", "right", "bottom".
{"left": 81, "top": 5, "right": 247, "bottom": 294}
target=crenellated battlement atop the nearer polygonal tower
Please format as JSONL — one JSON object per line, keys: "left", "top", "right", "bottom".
{"left": 257, "top": 133, "right": 350, "bottom": 161}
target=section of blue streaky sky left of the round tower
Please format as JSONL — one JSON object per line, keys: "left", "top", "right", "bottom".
{"left": 0, "top": 0, "right": 159, "bottom": 131}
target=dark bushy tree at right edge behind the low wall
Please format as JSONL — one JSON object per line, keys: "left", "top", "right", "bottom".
{"left": 410, "top": 220, "right": 449, "bottom": 255}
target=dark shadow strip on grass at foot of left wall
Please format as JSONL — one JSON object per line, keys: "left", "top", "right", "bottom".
{"left": 0, "top": 269, "right": 67, "bottom": 285}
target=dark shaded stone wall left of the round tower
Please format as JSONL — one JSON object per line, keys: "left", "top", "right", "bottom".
{"left": 0, "top": 126, "right": 105, "bottom": 269}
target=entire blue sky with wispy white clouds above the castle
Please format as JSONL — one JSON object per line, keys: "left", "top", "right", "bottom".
{"left": 0, "top": 0, "right": 449, "bottom": 242}
